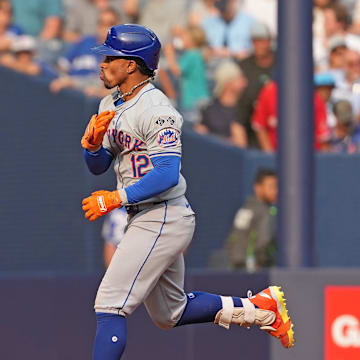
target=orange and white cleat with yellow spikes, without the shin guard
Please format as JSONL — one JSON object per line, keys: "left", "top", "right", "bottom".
{"left": 248, "top": 286, "right": 295, "bottom": 349}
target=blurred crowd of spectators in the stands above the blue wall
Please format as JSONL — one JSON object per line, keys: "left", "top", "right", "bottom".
{"left": 0, "top": 0, "right": 360, "bottom": 153}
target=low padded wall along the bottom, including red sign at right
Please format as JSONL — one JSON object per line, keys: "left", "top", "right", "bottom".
{"left": 0, "top": 269, "right": 360, "bottom": 360}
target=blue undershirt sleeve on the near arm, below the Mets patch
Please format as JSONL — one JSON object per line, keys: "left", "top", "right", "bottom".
{"left": 125, "top": 156, "right": 181, "bottom": 204}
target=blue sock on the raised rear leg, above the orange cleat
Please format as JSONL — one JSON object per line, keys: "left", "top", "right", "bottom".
{"left": 176, "top": 291, "right": 243, "bottom": 326}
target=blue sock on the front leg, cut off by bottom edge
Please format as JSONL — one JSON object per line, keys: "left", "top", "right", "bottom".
{"left": 93, "top": 313, "right": 126, "bottom": 360}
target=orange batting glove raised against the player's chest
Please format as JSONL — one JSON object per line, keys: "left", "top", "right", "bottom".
{"left": 81, "top": 110, "right": 115, "bottom": 151}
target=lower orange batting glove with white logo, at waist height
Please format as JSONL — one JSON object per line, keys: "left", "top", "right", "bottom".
{"left": 82, "top": 190, "right": 121, "bottom": 221}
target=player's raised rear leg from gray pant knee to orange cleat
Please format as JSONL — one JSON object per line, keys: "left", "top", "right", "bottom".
{"left": 145, "top": 255, "right": 295, "bottom": 348}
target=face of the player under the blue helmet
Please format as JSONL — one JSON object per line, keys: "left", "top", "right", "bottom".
{"left": 100, "top": 56, "right": 132, "bottom": 89}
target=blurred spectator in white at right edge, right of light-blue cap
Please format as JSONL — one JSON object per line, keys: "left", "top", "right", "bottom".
{"left": 332, "top": 49, "right": 360, "bottom": 119}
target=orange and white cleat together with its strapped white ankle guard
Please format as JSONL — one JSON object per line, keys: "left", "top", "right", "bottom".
{"left": 214, "top": 286, "right": 295, "bottom": 349}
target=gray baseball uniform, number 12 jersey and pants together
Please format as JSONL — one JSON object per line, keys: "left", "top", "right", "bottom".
{"left": 95, "top": 84, "right": 195, "bottom": 328}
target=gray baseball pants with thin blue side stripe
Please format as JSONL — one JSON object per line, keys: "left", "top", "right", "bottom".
{"left": 95, "top": 196, "right": 195, "bottom": 329}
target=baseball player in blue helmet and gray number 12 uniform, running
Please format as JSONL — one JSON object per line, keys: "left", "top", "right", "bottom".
{"left": 81, "top": 24, "right": 294, "bottom": 360}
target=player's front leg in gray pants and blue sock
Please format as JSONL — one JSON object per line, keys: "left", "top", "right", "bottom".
{"left": 94, "top": 201, "right": 194, "bottom": 360}
